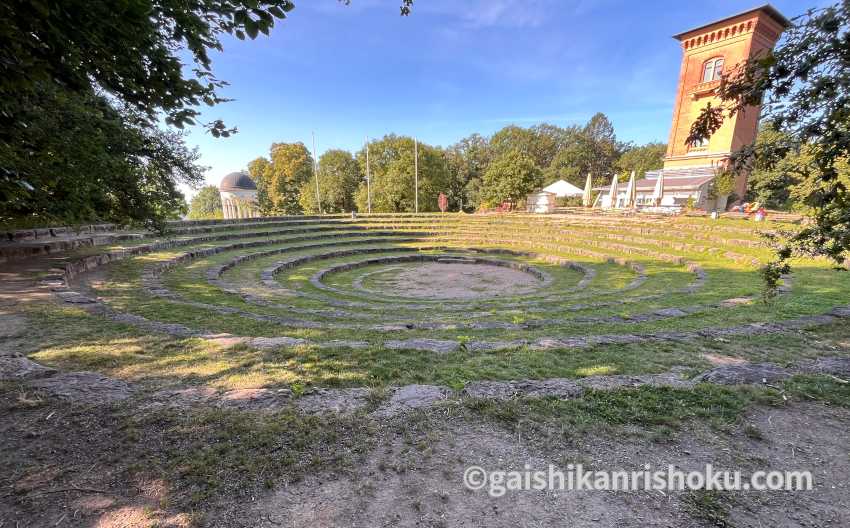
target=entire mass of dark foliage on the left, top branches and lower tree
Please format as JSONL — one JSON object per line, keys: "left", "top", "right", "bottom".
{"left": 0, "top": 0, "right": 293, "bottom": 229}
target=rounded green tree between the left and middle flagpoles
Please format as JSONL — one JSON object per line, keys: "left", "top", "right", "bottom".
{"left": 298, "top": 150, "right": 361, "bottom": 213}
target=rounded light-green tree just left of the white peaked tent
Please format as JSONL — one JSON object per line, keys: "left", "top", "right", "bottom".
{"left": 484, "top": 150, "right": 543, "bottom": 205}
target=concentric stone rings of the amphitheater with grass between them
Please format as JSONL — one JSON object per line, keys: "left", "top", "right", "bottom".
{"left": 51, "top": 215, "right": 844, "bottom": 366}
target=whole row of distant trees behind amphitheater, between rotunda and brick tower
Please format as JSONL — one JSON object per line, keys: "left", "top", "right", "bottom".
{"left": 193, "top": 113, "right": 667, "bottom": 215}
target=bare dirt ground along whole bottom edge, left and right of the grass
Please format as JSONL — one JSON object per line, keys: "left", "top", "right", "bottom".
{"left": 0, "top": 386, "right": 850, "bottom": 528}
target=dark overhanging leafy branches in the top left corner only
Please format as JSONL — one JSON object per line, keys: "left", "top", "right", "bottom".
{"left": 0, "top": 0, "right": 294, "bottom": 136}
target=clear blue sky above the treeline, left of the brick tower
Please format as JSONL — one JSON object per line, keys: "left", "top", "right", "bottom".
{"left": 181, "top": 0, "right": 817, "bottom": 194}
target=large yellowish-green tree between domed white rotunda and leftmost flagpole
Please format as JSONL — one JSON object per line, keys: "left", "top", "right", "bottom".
{"left": 248, "top": 142, "right": 315, "bottom": 215}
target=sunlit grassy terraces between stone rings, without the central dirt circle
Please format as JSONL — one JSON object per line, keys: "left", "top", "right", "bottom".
{"left": 36, "top": 211, "right": 850, "bottom": 387}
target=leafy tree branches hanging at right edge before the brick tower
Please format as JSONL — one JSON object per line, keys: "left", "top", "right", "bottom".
{"left": 687, "top": 0, "right": 850, "bottom": 268}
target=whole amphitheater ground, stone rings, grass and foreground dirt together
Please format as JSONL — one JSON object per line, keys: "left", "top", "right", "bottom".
{"left": 8, "top": 211, "right": 850, "bottom": 527}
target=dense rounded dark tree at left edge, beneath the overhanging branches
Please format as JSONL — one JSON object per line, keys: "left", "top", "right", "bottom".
{"left": 0, "top": 87, "right": 203, "bottom": 229}
